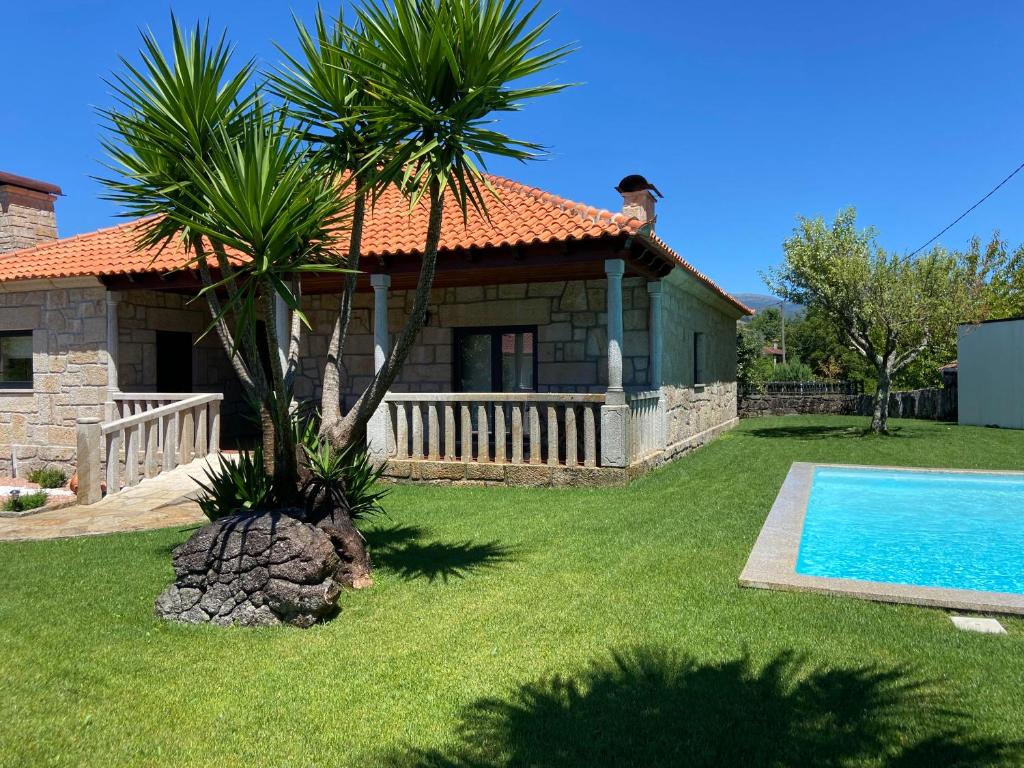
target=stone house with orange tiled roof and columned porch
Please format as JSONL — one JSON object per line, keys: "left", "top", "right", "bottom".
{"left": 0, "top": 167, "right": 751, "bottom": 495}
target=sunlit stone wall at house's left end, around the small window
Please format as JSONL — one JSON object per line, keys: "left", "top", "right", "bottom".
{"left": 0, "top": 280, "right": 106, "bottom": 476}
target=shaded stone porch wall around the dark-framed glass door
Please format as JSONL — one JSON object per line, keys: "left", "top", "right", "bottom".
{"left": 296, "top": 278, "right": 649, "bottom": 408}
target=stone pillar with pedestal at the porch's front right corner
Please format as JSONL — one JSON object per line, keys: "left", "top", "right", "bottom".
{"left": 601, "top": 259, "right": 630, "bottom": 467}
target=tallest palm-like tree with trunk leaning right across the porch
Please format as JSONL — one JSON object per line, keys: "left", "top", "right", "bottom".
{"left": 325, "top": 0, "right": 569, "bottom": 445}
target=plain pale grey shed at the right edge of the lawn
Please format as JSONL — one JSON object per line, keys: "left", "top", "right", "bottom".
{"left": 943, "top": 317, "right": 1024, "bottom": 429}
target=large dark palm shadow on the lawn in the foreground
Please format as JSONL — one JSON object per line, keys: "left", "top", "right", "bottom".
{"left": 385, "top": 648, "right": 1022, "bottom": 768}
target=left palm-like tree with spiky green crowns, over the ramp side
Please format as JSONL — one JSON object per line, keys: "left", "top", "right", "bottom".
{"left": 103, "top": 18, "right": 343, "bottom": 489}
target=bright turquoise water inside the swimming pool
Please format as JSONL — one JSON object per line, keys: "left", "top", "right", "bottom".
{"left": 797, "top": 467, "right": 1024, "bottom": 594}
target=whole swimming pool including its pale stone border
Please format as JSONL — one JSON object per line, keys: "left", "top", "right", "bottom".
{"left": 739, "top": 462, "right": 1024, "bottom": 613}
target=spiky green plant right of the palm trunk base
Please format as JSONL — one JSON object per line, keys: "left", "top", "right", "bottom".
{"left": 301, "top": 429, "right": 388, "bottom": 520}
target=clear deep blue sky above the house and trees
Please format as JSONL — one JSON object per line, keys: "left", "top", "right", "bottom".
{"left": 0, "top": 0, "right": 1024, "bottom": 292}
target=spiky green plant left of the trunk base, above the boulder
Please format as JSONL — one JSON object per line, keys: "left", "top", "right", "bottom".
{"left": 196, "top": 445, "right": 281, "bottom": 520}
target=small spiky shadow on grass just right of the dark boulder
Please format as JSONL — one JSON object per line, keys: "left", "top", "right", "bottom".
{"left": 364, "top": 525, "right": 513, "bottom": 582}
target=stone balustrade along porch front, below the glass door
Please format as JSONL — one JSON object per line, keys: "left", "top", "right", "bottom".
{"left": 385, "top": 392, "right": 604, "bottom": 467}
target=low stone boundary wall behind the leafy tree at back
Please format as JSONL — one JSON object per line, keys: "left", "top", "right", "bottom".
{"left": 739, "top": 387, "right": 956, "bottom": 421}
